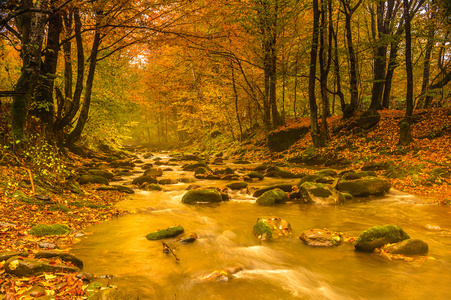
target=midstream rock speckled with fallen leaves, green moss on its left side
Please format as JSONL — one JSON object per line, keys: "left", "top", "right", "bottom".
{"left": 254, "top": 217, "right": 291, "bottom": 241}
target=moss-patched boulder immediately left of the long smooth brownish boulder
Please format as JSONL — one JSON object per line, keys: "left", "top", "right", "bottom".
{"left": 299, "top": 182, "right": 346, "bottom": 204}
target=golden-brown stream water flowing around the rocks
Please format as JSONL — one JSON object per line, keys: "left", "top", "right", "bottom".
{"left": 72, "top": 156, "right": 451, "bottom": 300}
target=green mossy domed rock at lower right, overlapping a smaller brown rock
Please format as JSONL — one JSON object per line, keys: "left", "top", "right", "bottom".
{"left": 354, "top": 225, "right": 410, "bottom": 252}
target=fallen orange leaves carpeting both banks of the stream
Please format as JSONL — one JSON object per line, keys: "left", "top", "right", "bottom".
{"left": 0, "top": 108, "right": 451, "bottom": 300}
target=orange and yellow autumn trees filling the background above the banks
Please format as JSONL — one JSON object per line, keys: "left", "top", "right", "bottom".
{"left": 0, "top": 0, "right": 451, "bottom": 146}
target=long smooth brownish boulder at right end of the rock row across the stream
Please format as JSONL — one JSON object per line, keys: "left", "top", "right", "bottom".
{"left": 337, "top": 176, "right": 391, "bottom": 196}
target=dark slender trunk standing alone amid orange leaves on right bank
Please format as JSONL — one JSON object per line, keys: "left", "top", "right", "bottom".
{"left": 398, "top": 0, "right": 413, "bottom": 146}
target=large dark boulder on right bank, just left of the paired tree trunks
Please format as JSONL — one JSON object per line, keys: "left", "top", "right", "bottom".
{"left": 268, "top": 127, "right": 309, "bottom": 152}
